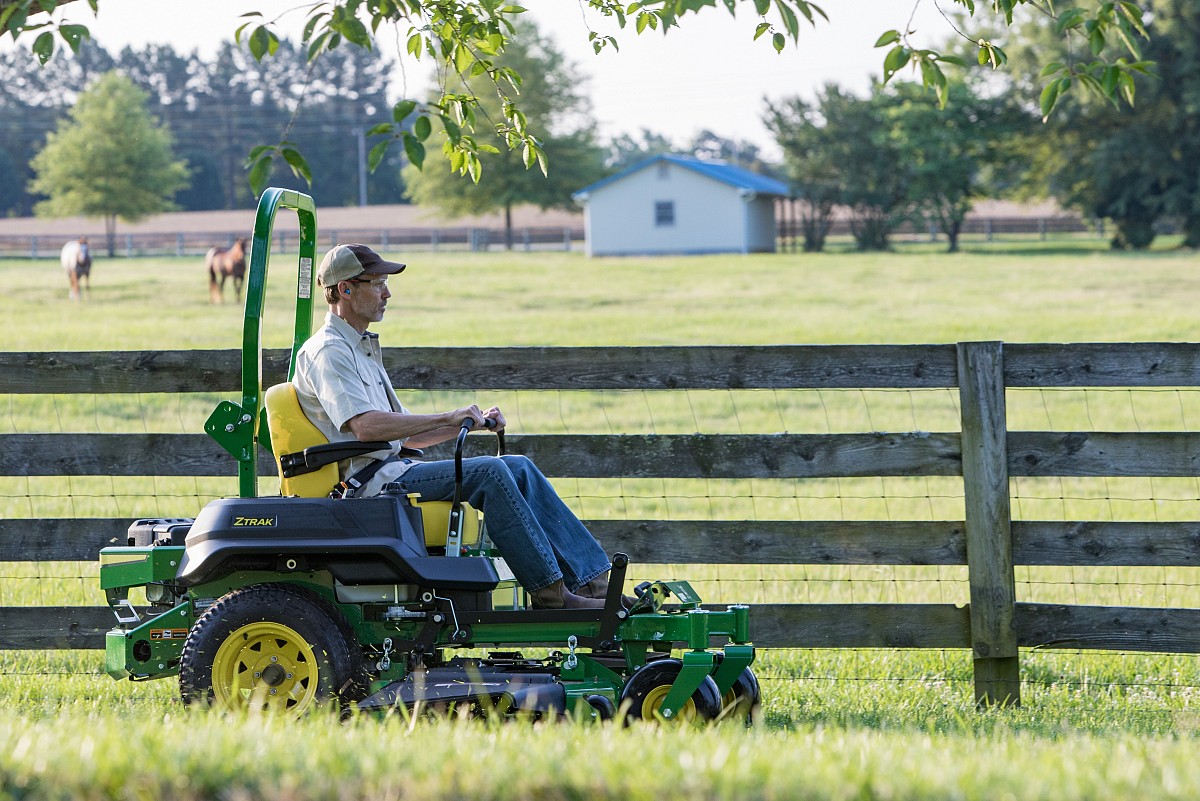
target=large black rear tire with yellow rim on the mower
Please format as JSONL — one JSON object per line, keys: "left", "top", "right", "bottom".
{"left": 179, "top": 584, "right": 367, "bottom": 716}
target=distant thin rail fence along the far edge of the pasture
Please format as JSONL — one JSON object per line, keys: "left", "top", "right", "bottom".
{"left": 0, "top": 216, "right": 1104, "bottom": 259}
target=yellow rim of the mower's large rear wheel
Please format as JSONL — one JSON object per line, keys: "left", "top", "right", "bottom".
{"left": 212, "top": 622, "right": 318, "bottom": 715}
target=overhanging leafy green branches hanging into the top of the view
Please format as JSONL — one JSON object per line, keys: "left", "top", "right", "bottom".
{"left": 0, "top": 0, "right": 1161, "bottom": 192}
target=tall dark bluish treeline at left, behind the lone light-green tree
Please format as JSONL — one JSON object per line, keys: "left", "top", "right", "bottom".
{"left": 0, "top": 41, "right": 403, "bottom": 216}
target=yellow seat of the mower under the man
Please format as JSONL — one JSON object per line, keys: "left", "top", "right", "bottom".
{"left": 263, "top": 381, "right": 480, "bottom": 548}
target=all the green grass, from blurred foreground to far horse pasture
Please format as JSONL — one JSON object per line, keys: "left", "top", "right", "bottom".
{"left": 0, "top": 241, "right": 1200, "bottom": 801}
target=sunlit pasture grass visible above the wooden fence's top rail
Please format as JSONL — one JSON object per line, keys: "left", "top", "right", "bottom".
{"left": 9, "top": 232, "right": 1200, "bottom": 350}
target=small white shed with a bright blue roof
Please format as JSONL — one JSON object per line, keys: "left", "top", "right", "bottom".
{"left": 572, "top": 156, "right": 788, "bottom": 255}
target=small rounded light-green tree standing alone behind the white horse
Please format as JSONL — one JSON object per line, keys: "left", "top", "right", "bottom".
{"left": 30, "top": 72, "right": 187, "bottom": 257}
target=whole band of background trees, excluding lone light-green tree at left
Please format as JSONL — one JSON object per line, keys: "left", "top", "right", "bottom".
{"left": 0, "top": 0, "right": 1200, "bottom": 251}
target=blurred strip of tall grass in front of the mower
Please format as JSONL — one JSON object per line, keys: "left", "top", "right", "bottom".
{"left": 0, "top": 661, "right": 1200, "bottom": 801}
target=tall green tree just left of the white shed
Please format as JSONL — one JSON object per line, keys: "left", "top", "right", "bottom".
{"left": 406, "top": 23, "right": 604, "bottom": 248}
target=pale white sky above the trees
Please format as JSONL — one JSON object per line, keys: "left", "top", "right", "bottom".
{"left": 7, "top": 0, "right": 954, "bottom": 156}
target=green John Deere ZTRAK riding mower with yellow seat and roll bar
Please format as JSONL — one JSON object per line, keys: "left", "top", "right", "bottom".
{"left": 100, "top": 188, "right": 760, "bottom": 723}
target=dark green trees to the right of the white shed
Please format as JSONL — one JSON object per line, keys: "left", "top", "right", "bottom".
{"left": 767, "top": 0, "right": 1200, "bottom": 251}
